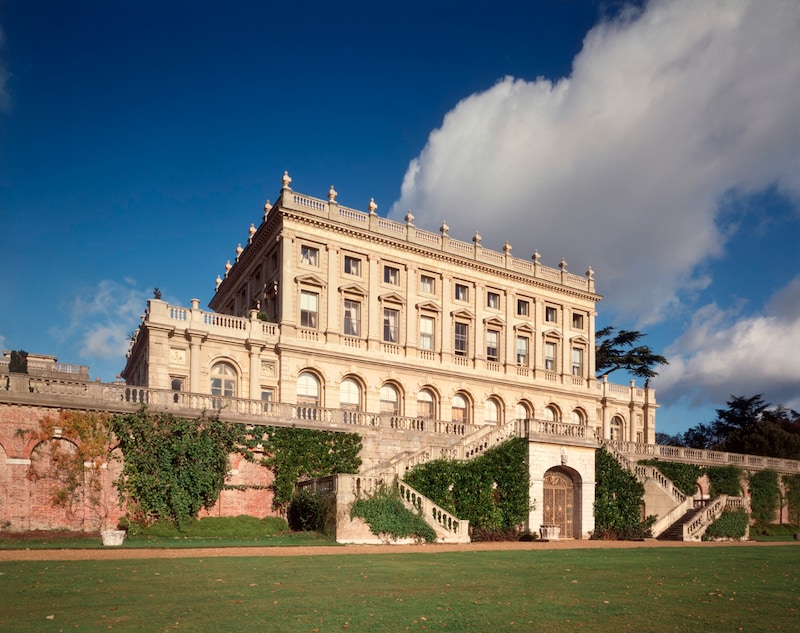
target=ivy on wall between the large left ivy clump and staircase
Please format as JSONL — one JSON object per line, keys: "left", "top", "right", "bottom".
{"left": 247, "top": 427, "right": 362, "bottom": 509}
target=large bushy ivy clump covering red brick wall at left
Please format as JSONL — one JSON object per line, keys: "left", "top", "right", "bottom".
{"left": 111, "top": 407, "right": 247, "bottom": 528}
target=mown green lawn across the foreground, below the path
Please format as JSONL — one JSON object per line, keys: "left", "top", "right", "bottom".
{"left": 0, "top": 545, "right": 800, "bottom": 633}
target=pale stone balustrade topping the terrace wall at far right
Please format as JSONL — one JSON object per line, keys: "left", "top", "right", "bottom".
{"left": 605, "top": 441, "right": 800, "bottom": 474}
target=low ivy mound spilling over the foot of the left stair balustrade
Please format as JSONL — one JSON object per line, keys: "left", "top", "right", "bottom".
{"left": 350, "top": 486, "right": 436, "bottom": 543}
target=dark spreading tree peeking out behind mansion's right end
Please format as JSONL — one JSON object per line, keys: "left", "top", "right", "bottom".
{"left": 595, "top": 325, "right": 669, "bottom": 379}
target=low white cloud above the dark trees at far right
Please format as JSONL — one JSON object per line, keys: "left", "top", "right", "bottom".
{"left": 654, "top": 277, "right": 800, "bottom": 410}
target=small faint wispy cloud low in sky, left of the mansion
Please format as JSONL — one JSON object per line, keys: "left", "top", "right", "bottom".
{"left": 59, "top": 279, "right": 148, "bottom": 360}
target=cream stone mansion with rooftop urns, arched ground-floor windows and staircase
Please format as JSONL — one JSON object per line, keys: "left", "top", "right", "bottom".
{"left": 0, "top": 174, "right": 796, "bottom": 542}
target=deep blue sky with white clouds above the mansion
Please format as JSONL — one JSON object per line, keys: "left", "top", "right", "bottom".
{"left": 0, "top": 0, "right": 800, "bottom": 433}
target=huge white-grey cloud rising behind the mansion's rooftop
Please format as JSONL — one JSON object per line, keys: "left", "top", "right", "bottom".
{"left": 390, "top": 0, "right": 800, "bottom": 326}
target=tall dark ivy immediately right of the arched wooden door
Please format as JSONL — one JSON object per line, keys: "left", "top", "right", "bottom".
{"left": 593, "top": 448, "right": 655, "bottom": 539}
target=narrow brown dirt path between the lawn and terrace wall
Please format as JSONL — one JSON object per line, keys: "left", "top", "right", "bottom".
{"left": 0, "top": 540, "right": 800, "bottom": 562}
